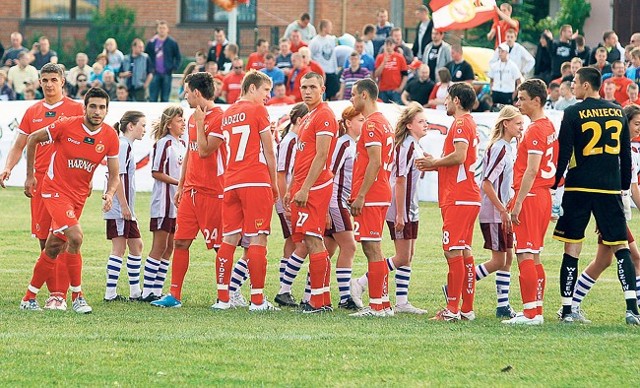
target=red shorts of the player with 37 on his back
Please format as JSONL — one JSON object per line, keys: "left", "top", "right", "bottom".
{"left": 222, "top": 186, "right": 273, "bottom": 237}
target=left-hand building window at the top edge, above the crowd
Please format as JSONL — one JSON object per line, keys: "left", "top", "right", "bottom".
{"left": 27, "top": 0, "right": 100, "bottom": 21}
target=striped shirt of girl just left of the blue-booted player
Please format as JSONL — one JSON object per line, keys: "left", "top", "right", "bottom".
{"left": 150, "top": 134, "right": 182, "bottom": 218}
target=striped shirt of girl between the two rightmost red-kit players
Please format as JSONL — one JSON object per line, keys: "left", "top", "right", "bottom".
{"left": 480, "top": 139, "right": 515, "bottom": 223}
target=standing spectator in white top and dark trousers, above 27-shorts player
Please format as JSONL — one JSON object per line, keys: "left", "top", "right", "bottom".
{"left": 309, "top": 19, "right": 340, "bottom": 101}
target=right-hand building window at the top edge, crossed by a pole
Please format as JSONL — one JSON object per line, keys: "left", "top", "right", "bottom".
{"left": 181, "top": 0, "right": 257, "bottom": 24}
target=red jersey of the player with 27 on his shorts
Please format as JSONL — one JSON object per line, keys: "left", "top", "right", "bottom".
{"left": 293, "top": 102, "right": 338, "bottom": 189}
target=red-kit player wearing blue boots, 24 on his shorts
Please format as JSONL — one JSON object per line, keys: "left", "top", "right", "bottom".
{"left": 151, "top": 72, "right": 226, "bottom": 307}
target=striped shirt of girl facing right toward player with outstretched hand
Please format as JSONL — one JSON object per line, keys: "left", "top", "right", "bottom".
{"left": 387, "top": 135, "right": 423, "bottom": 222}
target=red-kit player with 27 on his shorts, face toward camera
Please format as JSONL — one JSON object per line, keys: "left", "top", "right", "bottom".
{"left": 285, "top": 72, "right": 338, "bottom": 313}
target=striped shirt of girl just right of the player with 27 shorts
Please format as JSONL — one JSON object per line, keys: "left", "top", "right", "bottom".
{"left": 329, "top": 134, "right": 356, "bottom": 208}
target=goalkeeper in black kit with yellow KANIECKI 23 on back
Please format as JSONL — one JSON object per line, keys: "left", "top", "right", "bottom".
{"left": 553, "top": 67, "right": 640, "bottom": 325}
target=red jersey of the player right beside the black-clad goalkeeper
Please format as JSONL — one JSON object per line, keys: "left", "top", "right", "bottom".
{"left": 513, "top": 117, "right": 559, "bottom": 193}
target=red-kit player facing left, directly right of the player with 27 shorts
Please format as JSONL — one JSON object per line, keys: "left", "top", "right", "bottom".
{"left": 344, "top": 79, "right": 394, "bottom": 317}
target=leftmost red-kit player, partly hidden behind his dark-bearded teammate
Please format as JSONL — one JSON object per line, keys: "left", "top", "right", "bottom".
{"left": 0, "top": 63, "right": 84, "bottom": 310}
